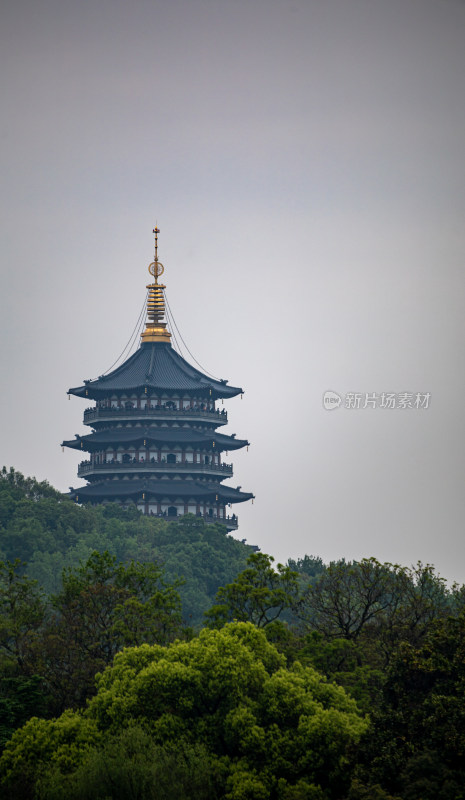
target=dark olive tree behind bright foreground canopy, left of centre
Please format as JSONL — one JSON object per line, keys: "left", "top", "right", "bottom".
{"left": 34, "top": 553, "right": 181, "bottom": 713}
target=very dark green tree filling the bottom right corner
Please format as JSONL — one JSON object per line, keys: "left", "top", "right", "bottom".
{"left": 350, "top": 614, "right": 465, "bottom": 800}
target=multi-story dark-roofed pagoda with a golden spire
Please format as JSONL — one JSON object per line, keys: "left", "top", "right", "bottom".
{"left": 63, "top": 228, "right": 253, "bottom": 530}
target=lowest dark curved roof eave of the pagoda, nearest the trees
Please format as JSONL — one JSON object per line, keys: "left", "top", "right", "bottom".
{"left": 68, "top": 480, "right": 255, "bottom": 503}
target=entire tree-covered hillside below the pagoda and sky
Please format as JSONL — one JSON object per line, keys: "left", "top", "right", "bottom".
{"left": 0, "top": 469, "right": 465, "bottom": 800}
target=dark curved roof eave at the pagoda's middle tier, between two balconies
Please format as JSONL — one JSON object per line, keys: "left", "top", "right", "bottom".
{"left": 61, "top": 428, "right": 249, "bottom": 453}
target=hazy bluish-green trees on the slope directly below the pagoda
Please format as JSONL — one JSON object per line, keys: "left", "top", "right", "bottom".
{"left": 0, "top": 467, "right": 251, "bottom": 626}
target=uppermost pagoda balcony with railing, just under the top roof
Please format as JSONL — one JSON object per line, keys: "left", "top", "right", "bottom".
{"left": 84, "top": 406, "right": 228, "bottom": 426}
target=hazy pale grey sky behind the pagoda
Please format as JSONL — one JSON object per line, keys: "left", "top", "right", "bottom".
{"left": 0, "top": 0, "right": 465, "bottom": 582}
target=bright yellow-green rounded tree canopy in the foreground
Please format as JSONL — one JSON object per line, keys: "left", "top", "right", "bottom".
{"left": 0, "top": 623, "right": 367, "bottom": 800}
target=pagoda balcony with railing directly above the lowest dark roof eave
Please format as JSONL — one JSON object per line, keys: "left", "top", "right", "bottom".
{"left": 78, "top": 461, "right": 233, "bottom": 479}
